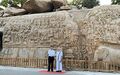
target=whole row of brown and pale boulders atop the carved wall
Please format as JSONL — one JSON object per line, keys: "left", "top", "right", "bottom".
{"left": 0, "top": 0, "right": 71, "bottom": 17}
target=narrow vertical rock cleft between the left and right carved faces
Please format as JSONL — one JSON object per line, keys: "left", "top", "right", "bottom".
{"left": 68, "top": 9, "right": 91, "bottom": 59}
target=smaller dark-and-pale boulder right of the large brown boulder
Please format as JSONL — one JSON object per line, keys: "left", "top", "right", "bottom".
{"left": 51, "top": 0, "right": 67, "bottom": 9}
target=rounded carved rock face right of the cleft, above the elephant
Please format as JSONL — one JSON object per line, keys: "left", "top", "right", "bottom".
{"left": 79, "top": 5, "right": 120, "bottom": 58}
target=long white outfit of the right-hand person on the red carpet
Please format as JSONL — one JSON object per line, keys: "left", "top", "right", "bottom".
{"left": 56, "top": 50, "right": 63, "bottom": 71}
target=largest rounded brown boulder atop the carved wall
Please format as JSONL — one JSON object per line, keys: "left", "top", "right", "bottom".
{"left": 23, "top": 0, "right": 53, "bottom": 13}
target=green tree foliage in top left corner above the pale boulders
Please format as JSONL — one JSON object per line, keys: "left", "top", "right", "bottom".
{"left": 1, "top": 0, "right": 26, "bottom": 7}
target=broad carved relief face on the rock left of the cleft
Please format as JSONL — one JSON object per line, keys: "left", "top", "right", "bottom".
{"left": 3, "top": 11, "right": 79, "bottom": 58}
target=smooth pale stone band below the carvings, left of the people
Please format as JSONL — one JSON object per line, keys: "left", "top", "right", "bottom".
{"left": 0, "top": 48, "right": 49, "bottom": 59}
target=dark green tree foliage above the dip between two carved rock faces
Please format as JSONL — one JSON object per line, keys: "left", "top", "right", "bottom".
{"left": 82, "top": 0, "right": 99, "bottom": 8}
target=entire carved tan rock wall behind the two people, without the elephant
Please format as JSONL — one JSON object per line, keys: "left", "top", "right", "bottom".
{"left": 0, "top": 5, "right": 120, "bottom": 61}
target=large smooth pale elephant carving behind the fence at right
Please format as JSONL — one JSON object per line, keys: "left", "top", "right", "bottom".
{"left": 94, "top": 46, "right": 120, "bottom": 64}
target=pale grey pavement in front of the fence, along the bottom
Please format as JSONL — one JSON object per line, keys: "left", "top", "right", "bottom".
{"left": 0, "top": 66, "right": 120, "bottom": 75}
